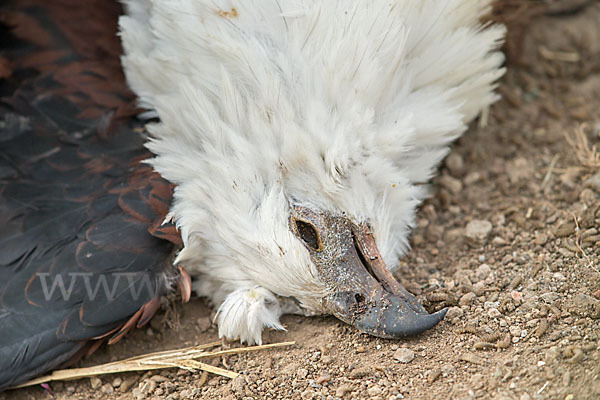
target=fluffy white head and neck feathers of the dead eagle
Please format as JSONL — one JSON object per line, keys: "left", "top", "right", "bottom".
{"left": 120, "top": 0, "right": 504, "bottom": 343}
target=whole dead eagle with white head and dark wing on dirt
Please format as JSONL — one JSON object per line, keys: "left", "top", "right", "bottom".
{"left": 0, "top": 0, "right": 505, "bottom": 390}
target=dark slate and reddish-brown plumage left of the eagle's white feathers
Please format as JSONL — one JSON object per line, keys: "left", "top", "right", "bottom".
{"left": 0, "top": 0, "right": 183, "bottom": 390}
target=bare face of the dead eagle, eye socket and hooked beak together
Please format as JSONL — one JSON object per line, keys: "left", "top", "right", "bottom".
{"left": 290, "top": 206, "right": 445, "bottom": 338}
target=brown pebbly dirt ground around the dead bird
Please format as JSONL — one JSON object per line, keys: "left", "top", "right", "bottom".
{"left": 0, "top": 2, "right": 600, "bottom": 400}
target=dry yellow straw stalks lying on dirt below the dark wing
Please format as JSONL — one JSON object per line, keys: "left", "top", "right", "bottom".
{"left": 14, "top": 341, "right": 296, "bottom": 388}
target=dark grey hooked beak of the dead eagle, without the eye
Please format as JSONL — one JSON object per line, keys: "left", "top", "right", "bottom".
{"left": 324, "top": 224, "right": 447, "bottom": 338}
